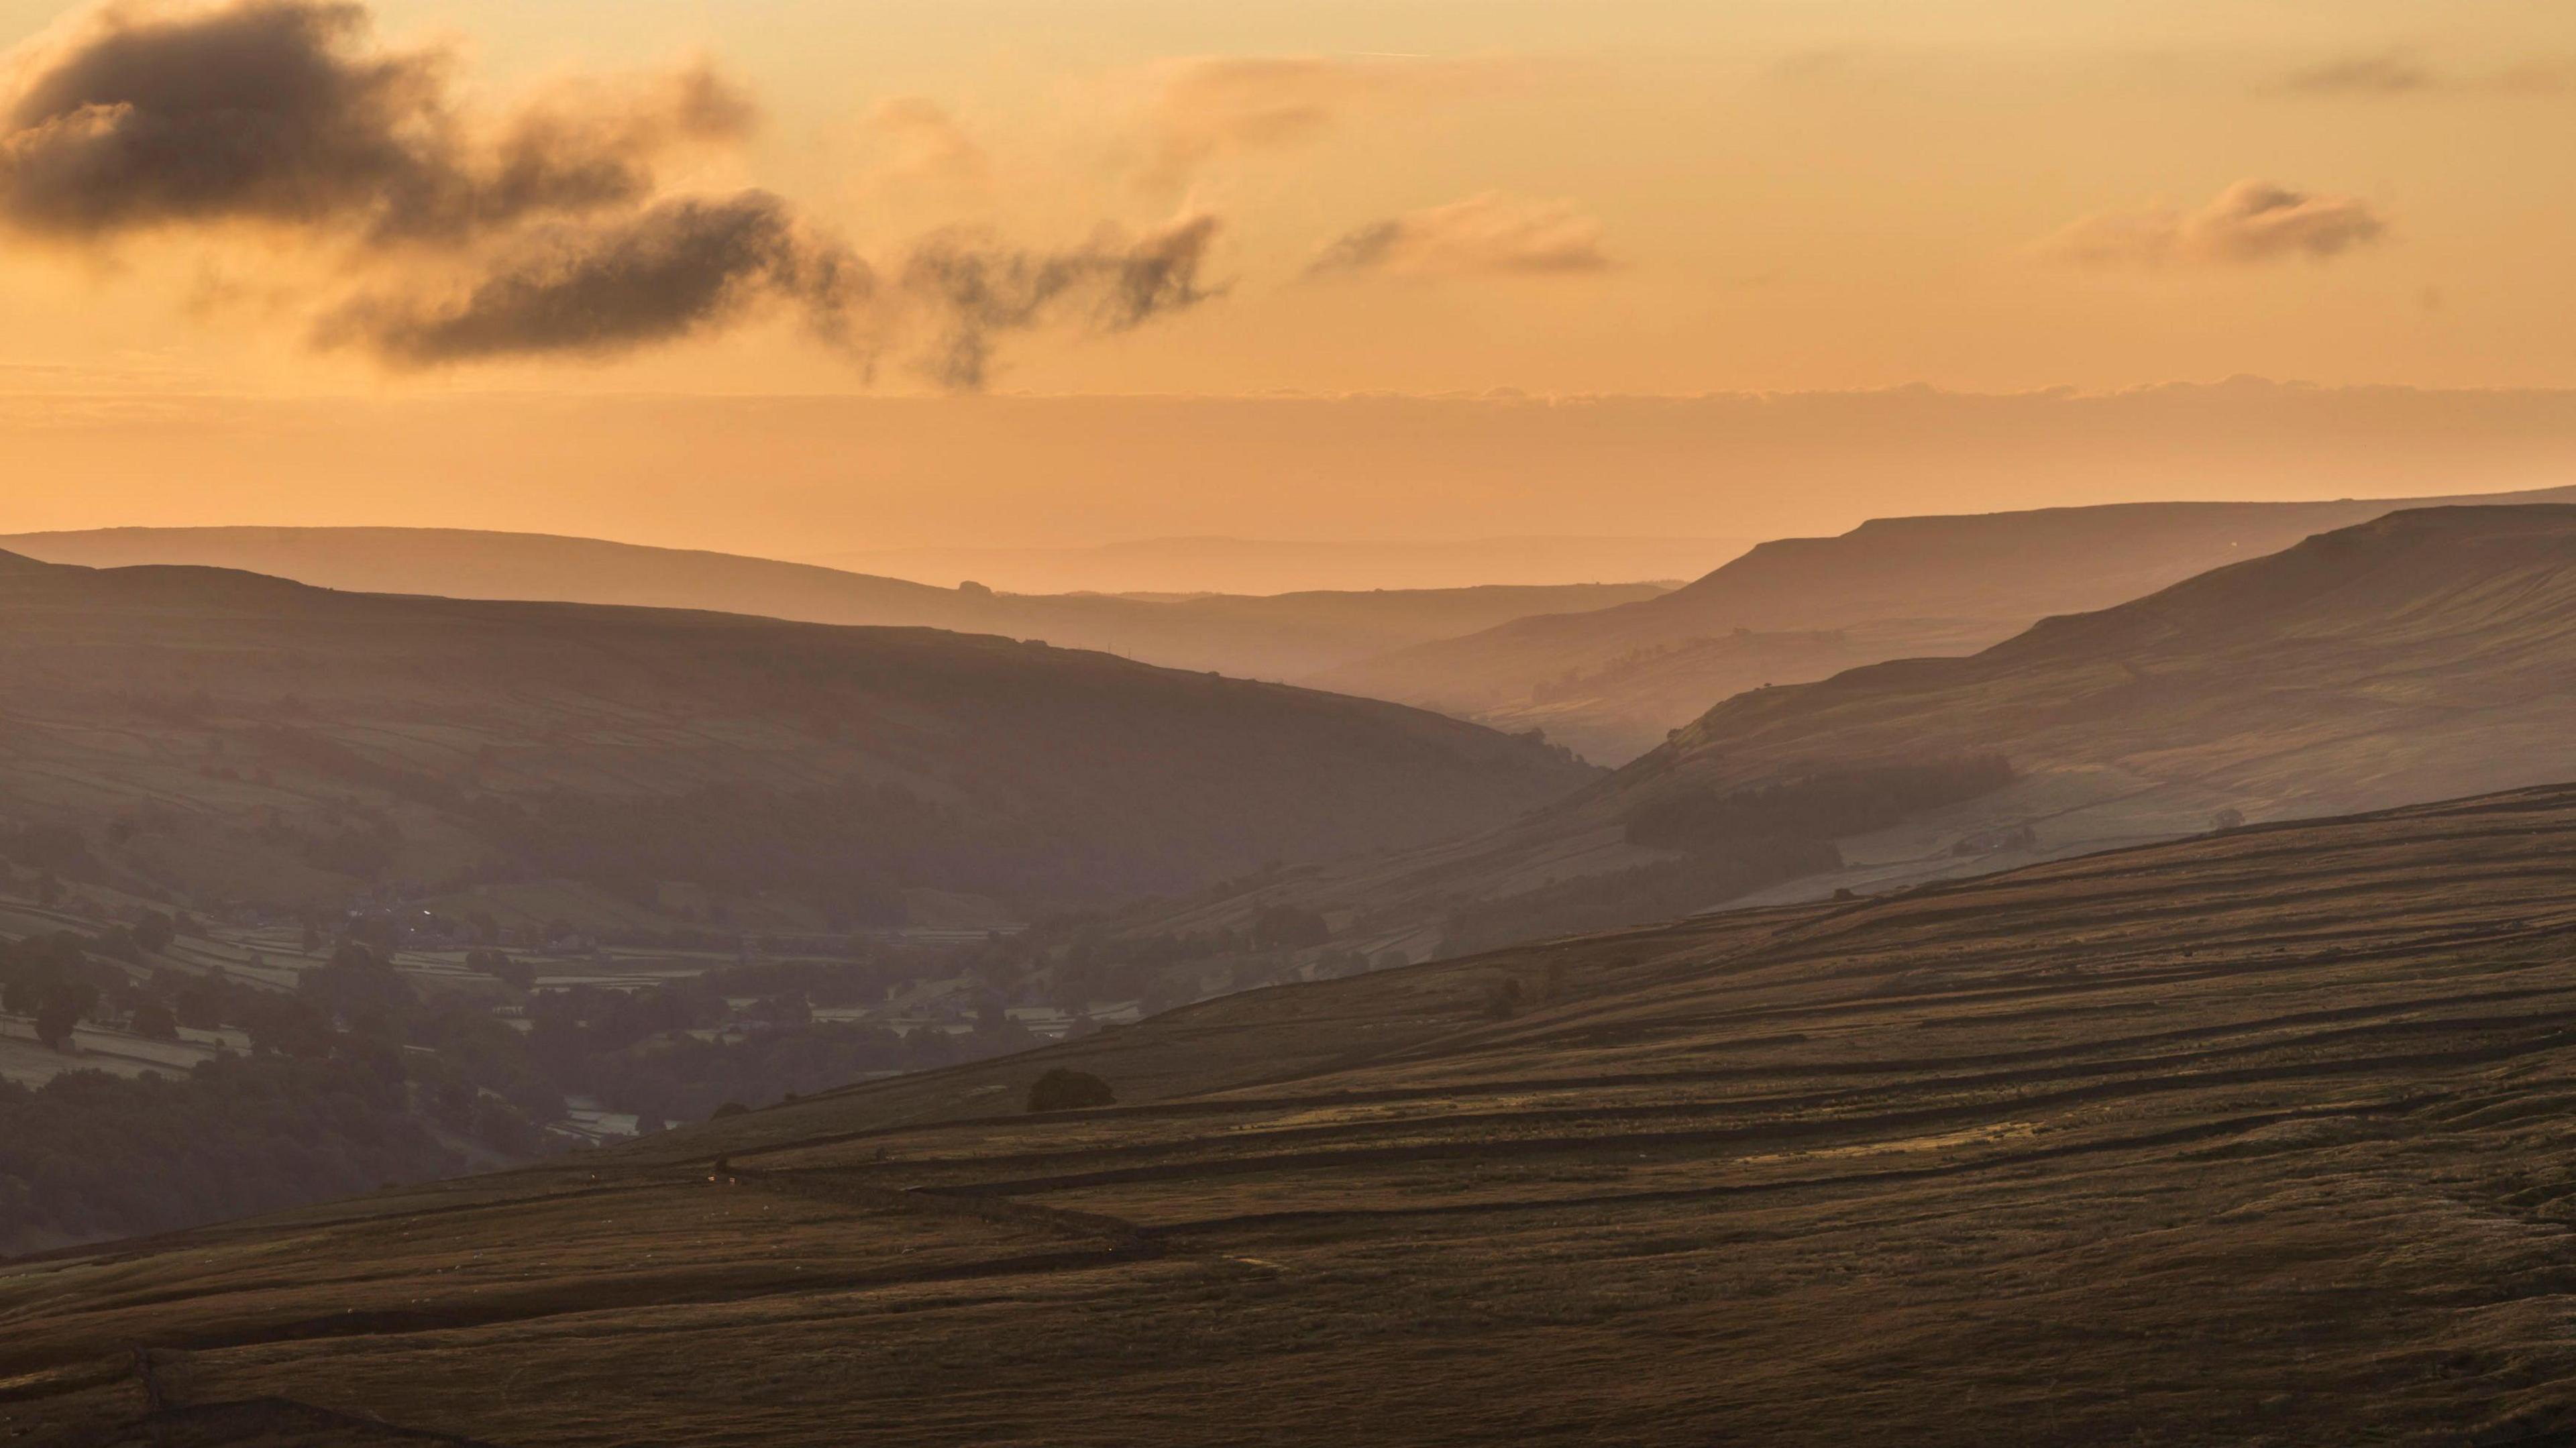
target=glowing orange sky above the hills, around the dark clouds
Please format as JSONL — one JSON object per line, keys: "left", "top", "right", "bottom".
{"left": 0, "top": 0, "right": 2576, "bottom": 551}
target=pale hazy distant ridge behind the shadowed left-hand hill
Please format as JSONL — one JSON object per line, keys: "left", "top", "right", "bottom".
{"left": 0, "top": 528, "right": 1664, "bottom": 680}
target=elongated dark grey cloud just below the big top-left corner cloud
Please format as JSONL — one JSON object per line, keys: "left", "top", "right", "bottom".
{"left": 319, "top": 190, "right": 873, "bottom": 366}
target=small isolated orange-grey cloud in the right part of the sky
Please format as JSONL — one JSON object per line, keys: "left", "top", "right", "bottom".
{"left": 2037, "top": 180, "right": 2388, "bottom": 266}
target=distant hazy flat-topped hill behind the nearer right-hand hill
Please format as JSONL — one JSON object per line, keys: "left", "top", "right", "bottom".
{"left": 1313, "top": 490, "right": 2576, "bottom": 763}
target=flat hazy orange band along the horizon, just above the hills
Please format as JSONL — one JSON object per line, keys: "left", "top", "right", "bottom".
{"left": 0, "top": 379, "right": 2576, "bottom": 567}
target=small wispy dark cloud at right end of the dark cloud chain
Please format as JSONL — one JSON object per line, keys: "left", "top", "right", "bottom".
{"left": 902, "top": 217, "right": 1216, "bottom": 386}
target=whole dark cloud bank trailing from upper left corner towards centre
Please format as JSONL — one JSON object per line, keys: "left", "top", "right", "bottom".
{"left": 0, "top": 0, "right": 1216, "bottom": 386}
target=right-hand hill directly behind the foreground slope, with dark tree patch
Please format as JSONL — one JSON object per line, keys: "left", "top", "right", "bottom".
{"left": 1172, "top": 505, "right": 2576, "bottom": 958}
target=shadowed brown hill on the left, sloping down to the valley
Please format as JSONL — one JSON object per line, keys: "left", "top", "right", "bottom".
{"left": 0, "top": 557, "right": 1592, "bottom": 928}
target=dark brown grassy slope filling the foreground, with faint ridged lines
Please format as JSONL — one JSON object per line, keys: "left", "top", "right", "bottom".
{"left": 15, "top": 789, "right": 2576, "bottom": 1448}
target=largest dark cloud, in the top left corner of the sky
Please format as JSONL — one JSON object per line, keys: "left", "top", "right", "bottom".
{"left": 0, "top": 0, "right": 749, "bottom": 242}
